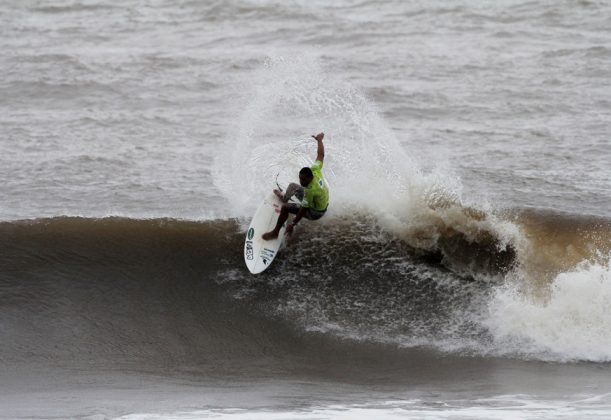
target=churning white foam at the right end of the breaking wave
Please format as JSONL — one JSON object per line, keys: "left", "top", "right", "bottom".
{"left": 486, "top": 262, "right": 611, "bottom": 362}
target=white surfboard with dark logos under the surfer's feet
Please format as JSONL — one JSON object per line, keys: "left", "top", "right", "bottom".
{"left": 244, "top": 193, "right": 286, "bottom": 274}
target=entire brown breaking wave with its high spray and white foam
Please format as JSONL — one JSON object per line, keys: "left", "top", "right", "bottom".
{"left": 0, "top": 48, "right": 611, "bottom": 372}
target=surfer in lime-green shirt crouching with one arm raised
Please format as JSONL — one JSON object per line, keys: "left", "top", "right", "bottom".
{"left": 262, "top": 133, "right": 329, "bottom": 240}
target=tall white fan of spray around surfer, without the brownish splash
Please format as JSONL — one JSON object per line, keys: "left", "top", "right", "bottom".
{"left": 214, "top": 57, "right": 428, "bottom": 217}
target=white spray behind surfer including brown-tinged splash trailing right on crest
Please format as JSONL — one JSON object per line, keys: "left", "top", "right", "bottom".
{"left": 213, "top": 54, "right": 516, "bottom": 262}
